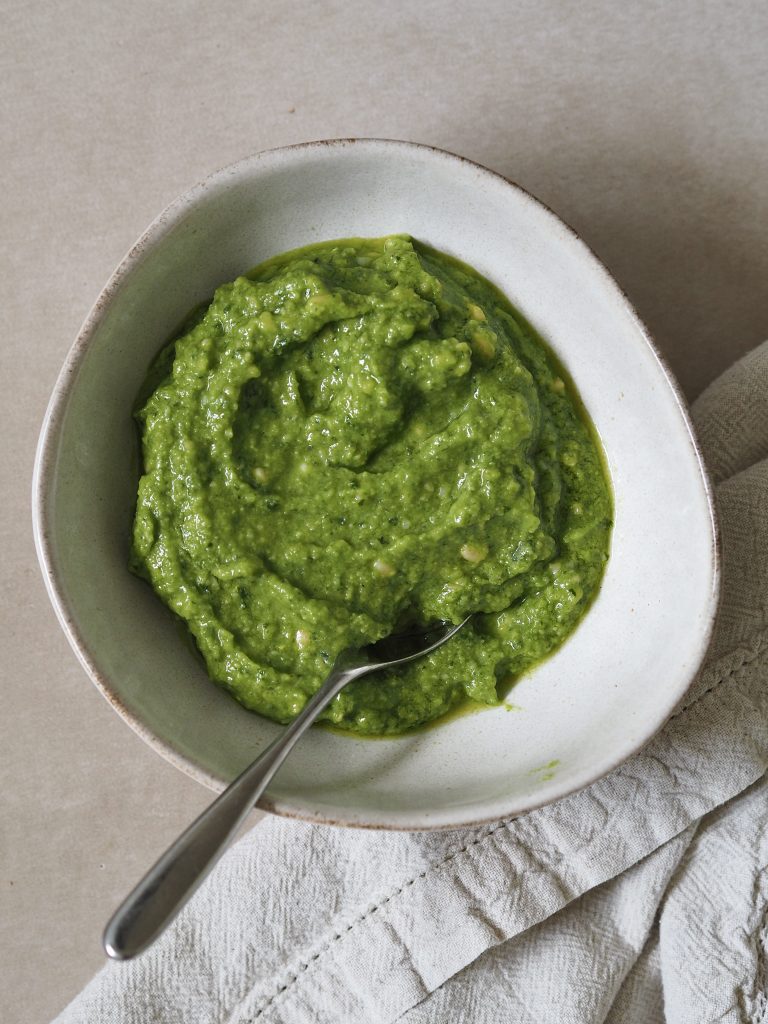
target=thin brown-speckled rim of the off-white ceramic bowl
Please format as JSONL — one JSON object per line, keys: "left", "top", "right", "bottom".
{"left": 32, "top": 136, "right": 722, "bottom": 831}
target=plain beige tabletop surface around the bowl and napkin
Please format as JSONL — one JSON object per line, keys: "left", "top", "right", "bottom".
{"left": 0, "top": 0, "right": 768, "bottom": 1024}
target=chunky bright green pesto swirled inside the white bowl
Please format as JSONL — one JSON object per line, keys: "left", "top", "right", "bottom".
{"left": 132, "top": 236, "right": 612, "bottom": 735}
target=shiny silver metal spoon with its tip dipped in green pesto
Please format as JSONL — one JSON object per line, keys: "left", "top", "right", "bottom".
{"left": 103, "top": 617, "right": 469, "bottom": 959}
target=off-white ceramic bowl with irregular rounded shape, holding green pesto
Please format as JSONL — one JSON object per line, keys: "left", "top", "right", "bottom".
{"left": 34, "top": 139, "right": 718, "bottom": 828}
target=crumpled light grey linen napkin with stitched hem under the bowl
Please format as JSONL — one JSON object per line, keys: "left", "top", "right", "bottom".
{"left": 57, "top": 342, "right": 768, "bottom": 1024}
